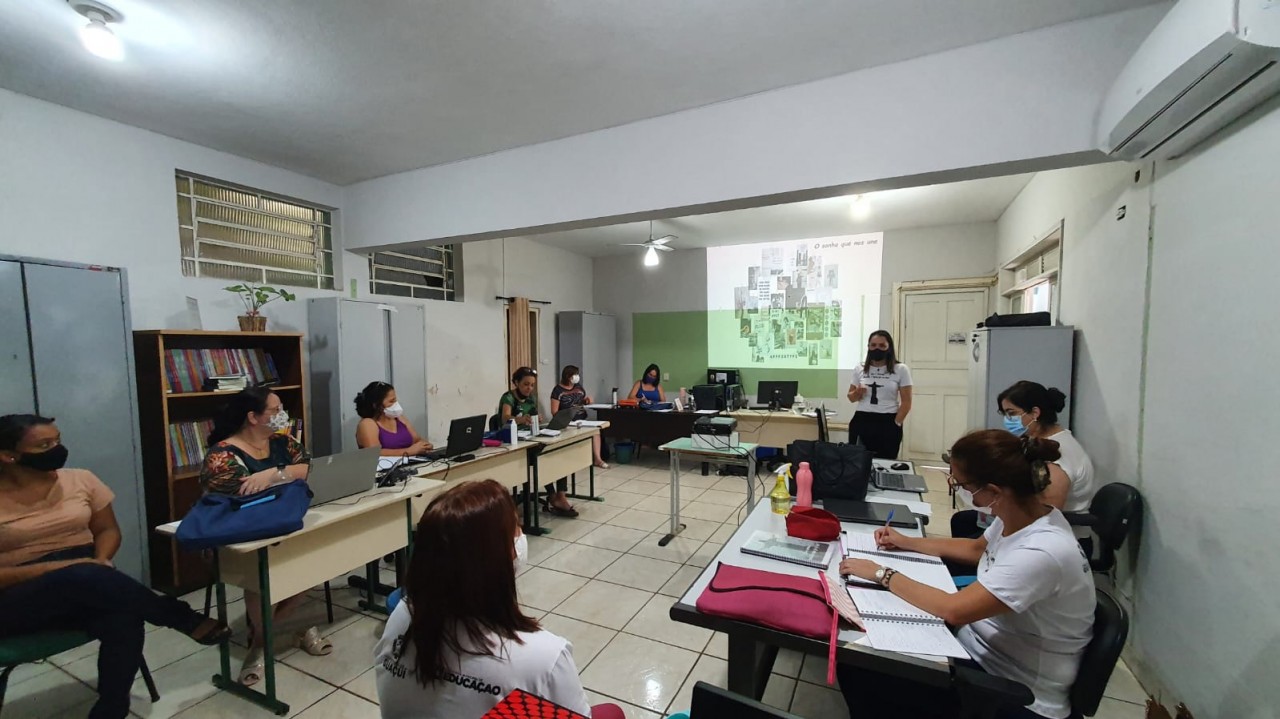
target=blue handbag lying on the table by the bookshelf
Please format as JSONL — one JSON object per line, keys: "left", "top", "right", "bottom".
{"left": 174, "top": 480, "right": 311, "bottom": 550}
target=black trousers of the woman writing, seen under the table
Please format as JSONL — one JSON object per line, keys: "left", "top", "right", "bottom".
{"left": 836, "top": 664, "right": 1044, "bottom": 719}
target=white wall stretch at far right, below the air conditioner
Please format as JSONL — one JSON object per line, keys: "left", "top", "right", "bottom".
{"left": 1130, "top": 96, "right": 1280, "bottom": 719}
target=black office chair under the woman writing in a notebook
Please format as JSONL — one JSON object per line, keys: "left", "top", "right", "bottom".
{"left": 955, "top": 590, "right": 1129, "bottom": 719}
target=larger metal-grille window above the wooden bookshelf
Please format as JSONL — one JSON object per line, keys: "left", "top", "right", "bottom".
{"left": 177, "top": 173, "right": 334, "bottom": 289}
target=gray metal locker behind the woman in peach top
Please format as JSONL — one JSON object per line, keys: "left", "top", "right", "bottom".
{"left": 0, "top": 256, "right": 148, "bottom": 583}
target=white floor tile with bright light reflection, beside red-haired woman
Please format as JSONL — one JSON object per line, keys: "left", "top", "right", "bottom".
{"left": 582, "top": 633, "right": 698, "bottom": 713}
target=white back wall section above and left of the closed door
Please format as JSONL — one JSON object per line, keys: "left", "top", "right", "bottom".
{"left": 881, "top": 223, "right": 996, "bottom": 331}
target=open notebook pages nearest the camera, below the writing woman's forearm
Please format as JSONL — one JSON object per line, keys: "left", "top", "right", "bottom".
{"left": 849, "top": 587, "right": 969, "bottom": 659}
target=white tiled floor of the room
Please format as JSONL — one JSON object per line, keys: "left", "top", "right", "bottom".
{"left": 4, "top": 452, "right": 1146, "bottom": 719}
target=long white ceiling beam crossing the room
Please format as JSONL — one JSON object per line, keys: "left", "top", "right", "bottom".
{"left": 346, "top": 4, "right": 1169, "bottom": 247}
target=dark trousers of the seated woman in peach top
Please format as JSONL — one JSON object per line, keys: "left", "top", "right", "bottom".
{"left": 0, "top": 546, "right": 204, "bottom": 719}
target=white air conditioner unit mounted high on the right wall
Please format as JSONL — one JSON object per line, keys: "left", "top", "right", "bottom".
{"left": 1098, "top": 0, "right": 1280, "bottom": 160}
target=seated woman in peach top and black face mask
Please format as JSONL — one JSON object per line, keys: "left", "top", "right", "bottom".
{"left": 0, "top": 415, "right": 230, "bottom": 719}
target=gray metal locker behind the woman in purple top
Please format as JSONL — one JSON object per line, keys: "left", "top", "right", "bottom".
{"left": 307, "top": 297, "right": 426, "bottom": 455}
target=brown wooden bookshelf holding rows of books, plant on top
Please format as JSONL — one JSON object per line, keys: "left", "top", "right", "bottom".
{"left": 133, "top": 330, "right": 311, "bottom": 594}
